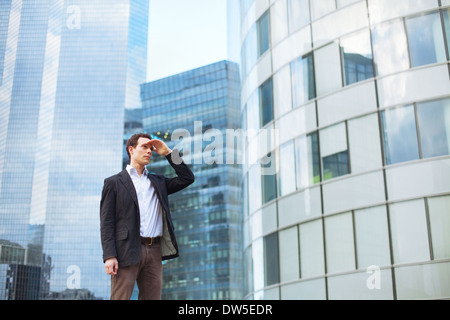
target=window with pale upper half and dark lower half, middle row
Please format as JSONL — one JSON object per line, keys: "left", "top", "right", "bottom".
{"left": 320, "top": 122, "right": 350, "bottom": 180}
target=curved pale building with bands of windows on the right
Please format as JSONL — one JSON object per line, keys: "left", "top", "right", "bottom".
{"left": 240, "top": 0, "right": 450, "bottom": 299}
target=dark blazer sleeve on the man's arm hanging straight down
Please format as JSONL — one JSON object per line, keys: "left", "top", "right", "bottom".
{"left": 100, "top": 179, "right": 117, "bottom": 262}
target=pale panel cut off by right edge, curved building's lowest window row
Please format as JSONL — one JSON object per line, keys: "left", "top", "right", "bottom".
{"left": 428, "top": 196, "right": 450, "bottom": 259}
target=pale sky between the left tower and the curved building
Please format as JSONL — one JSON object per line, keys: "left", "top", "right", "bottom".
{"left": 147, "top": 0, "right": 227, "bottom": 81}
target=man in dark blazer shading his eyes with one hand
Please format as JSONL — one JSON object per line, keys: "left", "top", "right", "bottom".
{"left": 100, "top": 133, "right": 194, "bottom": 300}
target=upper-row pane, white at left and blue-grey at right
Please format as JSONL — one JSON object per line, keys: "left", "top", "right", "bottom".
{"left": 291, "top": 54, "right": 316, "bottom": 108}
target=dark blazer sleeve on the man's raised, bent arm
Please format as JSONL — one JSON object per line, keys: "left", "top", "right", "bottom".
{"left": 165, "top": 149, "right": 195, "bottom": 194}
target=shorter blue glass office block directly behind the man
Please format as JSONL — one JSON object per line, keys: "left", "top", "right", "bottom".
{"left": 141, "top": 61, "right": 243, "bottom": 300}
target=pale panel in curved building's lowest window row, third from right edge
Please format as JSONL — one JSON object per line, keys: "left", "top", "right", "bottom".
{"left": 355, "top": 206, "right": 391, "bottom": 269}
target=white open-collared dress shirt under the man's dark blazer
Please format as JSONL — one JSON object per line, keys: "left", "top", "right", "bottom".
{"left": 126, "top": 165, "right": 163, "bottom": 238}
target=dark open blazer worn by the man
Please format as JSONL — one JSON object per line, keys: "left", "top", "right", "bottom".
{"left": 100, "top": 149, "right": 195, "bottom": 267}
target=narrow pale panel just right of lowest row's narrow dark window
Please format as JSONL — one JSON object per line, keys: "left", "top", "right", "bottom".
{"left": 279, "top": 226, "right": 299, "bottom": 282}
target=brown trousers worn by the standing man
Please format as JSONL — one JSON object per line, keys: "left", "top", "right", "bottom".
{"left": 111, "top": 243, "right": 162, "bottom": 300}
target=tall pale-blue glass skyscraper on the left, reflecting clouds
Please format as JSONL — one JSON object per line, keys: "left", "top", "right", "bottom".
{"left": 0, "top": 0, "right": 149, "bottom": 299}
